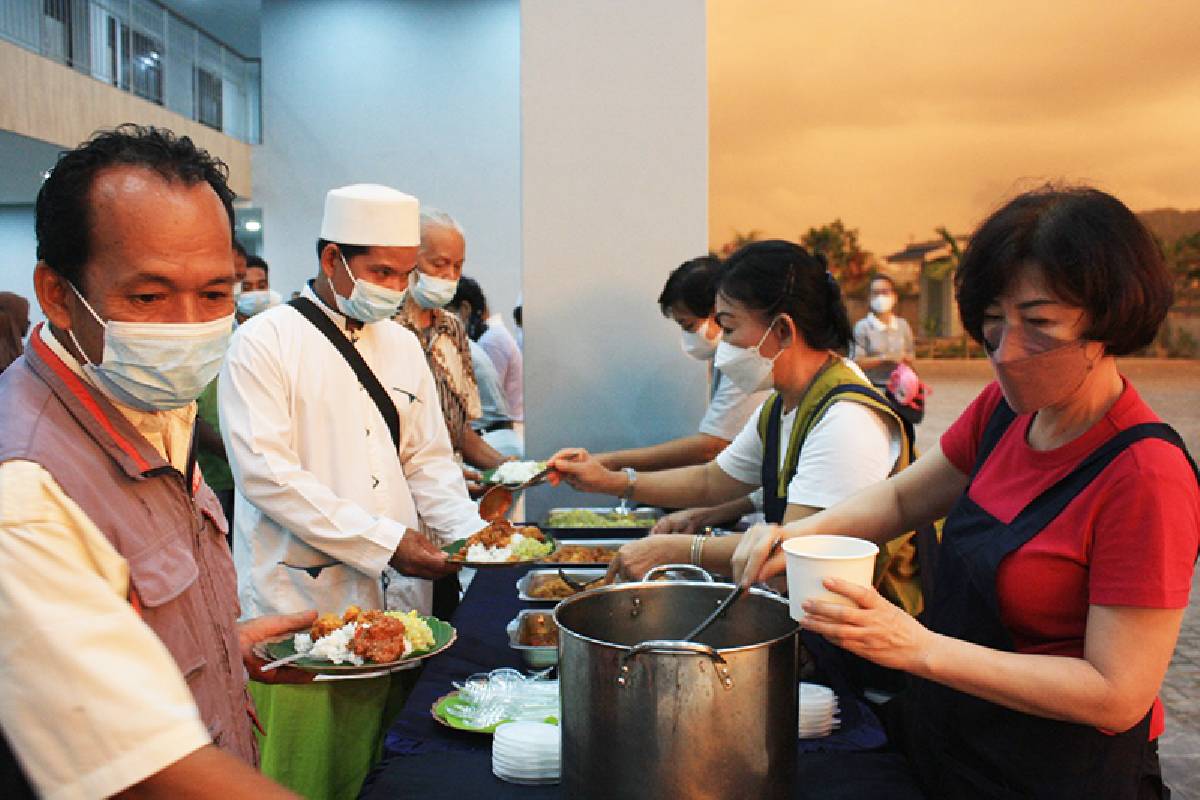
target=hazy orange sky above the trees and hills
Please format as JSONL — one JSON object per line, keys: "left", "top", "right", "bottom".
{"left": 708, "top": 0, "right": 1200, "bottom": 254}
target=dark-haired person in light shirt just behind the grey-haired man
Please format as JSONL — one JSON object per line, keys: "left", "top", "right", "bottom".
{"left": 446, "top": 277, "right": 524, "bottom": 458}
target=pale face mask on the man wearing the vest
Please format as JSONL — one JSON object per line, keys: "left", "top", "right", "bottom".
{"left": 67, "top": 284, "right": 233, "bottom": 411}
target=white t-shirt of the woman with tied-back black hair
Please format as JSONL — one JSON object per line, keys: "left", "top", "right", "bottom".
{"left": 716, "top": 391, "right": 901, "bottom": 509}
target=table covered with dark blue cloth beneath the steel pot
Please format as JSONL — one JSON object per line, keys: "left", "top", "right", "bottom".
{"left": 360, "top": 567, "right": 920, "bottom": 800}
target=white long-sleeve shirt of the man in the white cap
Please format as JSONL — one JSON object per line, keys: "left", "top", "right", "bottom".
{"left": 218, "top": 287, "right": 486, "bottom": 616}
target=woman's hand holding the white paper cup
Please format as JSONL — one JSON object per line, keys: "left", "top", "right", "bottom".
{"left": 800, "top": 578, "right": 937, "bottom": 673}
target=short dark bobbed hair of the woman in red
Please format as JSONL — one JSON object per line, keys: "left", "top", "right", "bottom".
{"left": 954, "top": 185, "right": 1174, "bottom": 355}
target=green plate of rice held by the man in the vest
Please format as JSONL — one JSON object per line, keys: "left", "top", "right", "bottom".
{"left": 259, "top": 606, "right": 457, "bottom": 675}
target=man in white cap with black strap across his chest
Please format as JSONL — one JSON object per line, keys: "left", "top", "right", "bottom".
{"left": 220, "top": 185, "right": 485, "bottom": 798}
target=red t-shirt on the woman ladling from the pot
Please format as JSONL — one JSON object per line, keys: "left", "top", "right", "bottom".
{"left": 941, "top": 381, "right": 1200, "bottom": 738}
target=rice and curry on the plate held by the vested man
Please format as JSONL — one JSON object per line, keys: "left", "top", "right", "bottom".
{"left": 294, "top": 606, "right": 433, "bottom": 667}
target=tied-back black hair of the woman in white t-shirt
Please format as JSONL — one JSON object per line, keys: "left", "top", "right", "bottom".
{"left": 718, "top": 239, "right": 851, "bottom": 350}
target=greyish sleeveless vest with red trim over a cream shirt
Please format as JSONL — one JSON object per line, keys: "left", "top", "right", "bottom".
{"left": 0, "top": 331, "right": 258, "bottom": 765}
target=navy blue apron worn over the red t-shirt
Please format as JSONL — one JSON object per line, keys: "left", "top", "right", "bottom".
{"left": 902, "top": 401, "right": 1200, "bottom": 800}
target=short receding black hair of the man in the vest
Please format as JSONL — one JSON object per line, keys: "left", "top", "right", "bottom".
{"left": 34, "top": 124, "right": 235, "bottom": 290}
